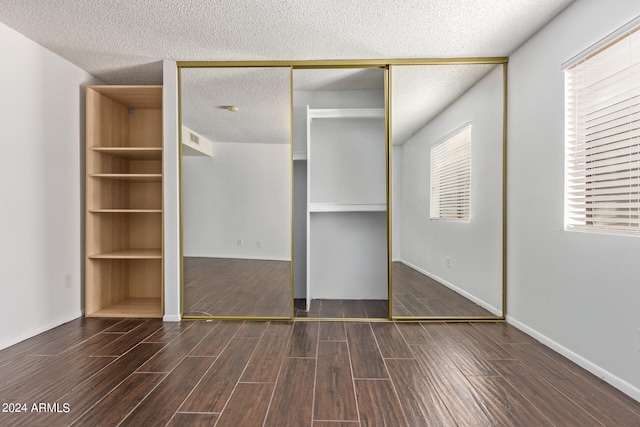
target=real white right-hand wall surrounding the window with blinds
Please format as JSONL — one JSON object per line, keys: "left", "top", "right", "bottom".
{"left": 507, "top": 0, "right": 640, "bottom": 399}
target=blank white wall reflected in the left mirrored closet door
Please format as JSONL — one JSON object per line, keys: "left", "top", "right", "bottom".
{"left": 182, "top": 142, "right": 291, "bottom": 260}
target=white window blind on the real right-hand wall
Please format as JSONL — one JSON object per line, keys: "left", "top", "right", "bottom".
{"left": 565, "top": 25, "right": 640, "bottom": 234}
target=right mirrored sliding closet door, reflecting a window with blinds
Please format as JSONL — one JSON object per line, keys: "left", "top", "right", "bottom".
{"left": 390, "top": 63, "right": 506, "bottom": 319}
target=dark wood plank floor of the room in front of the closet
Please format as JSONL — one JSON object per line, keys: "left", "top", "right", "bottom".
{"left": 0, "top": 318, "right": 640, "bottom": 427}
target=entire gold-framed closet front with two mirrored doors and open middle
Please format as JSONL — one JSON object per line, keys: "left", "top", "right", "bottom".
{"left": 178, "top": 58, "right": 506, "bottom": 320}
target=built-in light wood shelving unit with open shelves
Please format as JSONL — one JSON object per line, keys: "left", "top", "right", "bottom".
{"left": 85, "top": 86, "right": 164, "bottom": 317}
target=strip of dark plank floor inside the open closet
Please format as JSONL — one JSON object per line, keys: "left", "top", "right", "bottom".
{"left": 294, "top": 299, "right": 389, "bottom": 319}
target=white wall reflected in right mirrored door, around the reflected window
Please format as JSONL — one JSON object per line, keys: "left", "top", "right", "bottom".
{"left": 393, "top": 66, "right": 503, "bottom": 314}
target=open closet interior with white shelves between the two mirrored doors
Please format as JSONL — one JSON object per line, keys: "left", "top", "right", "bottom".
{"left": 293, "top": 68, "right": 389, "bottom": 317}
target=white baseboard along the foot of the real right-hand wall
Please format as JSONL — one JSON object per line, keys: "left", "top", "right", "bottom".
{"left": 506, "top": 316, "right": 640, "bottom": 402}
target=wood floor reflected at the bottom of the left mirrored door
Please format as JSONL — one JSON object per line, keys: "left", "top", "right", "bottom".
{"left": 184, "top": 257, "right": 291, "bottom": 317}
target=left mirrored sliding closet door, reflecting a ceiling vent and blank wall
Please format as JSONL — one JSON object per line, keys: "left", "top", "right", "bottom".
{"left": 179, "top": 67, "right": 293, "bottom": 318}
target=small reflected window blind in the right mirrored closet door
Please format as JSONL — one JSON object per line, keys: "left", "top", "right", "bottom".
{"left": 430, "top": 123, "right": 471, "bottom": 221}
